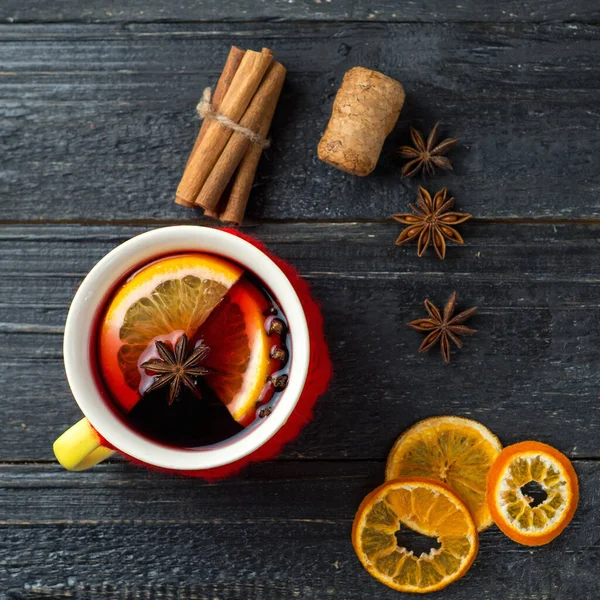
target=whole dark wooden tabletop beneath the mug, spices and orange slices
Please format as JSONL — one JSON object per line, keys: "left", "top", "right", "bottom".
{"left": 0, "top": 0, "right": 600, "bottom": 600}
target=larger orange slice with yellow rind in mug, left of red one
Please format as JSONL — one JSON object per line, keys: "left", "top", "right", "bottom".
{"left": 98, "top": 253, "right": 243, "bottom": 412}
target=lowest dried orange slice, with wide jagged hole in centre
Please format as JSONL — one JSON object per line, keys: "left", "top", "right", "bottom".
{"left": 352, "top": 477, "right": 479, "bottom": 593}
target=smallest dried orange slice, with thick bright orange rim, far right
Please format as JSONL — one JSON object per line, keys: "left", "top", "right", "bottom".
{"left": 487, "top": 441, "right": 579, "bottom": 546}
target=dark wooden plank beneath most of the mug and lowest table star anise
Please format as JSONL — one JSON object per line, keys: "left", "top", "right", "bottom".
{"left": 0, "top": 222, "right": 600, "bottom": 460}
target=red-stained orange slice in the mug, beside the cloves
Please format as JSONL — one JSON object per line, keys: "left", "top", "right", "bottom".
{"left": 198, "top": 279, "right": 280, "bottom": 425}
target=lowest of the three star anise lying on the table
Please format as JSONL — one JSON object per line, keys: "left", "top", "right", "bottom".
{"left": 408, "top": 292, "right": 478, "bottom": 364}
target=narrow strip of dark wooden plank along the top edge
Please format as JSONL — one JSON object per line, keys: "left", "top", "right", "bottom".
{"left": 0, "top": 0, "right": 600, "bottom": 23}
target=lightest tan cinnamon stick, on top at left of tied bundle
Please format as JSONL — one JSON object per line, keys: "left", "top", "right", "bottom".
{"left": 176, "top": 49, "right": 273, "bottom": 206}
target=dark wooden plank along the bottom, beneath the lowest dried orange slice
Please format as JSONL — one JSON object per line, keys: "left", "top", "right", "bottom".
{"left": 0, "top": 461, "right": 600, "bottom": 600}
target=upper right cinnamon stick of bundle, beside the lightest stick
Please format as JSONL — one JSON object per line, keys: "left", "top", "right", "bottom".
{"left": 196, "top": 62, "right": 286, "bottom": 212}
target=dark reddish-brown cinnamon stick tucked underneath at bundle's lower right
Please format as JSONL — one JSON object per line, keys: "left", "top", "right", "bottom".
{"left": 221, "top": 69, "right": 285, "bottom": 225}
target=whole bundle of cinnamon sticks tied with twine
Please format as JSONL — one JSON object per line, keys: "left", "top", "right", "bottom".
{"left": 175, "top": 47, "right": 286, "bottom": 225}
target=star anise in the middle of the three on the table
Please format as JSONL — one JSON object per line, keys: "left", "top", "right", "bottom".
{"left": 392, "top": 186, "right": 471, "bottom": 259}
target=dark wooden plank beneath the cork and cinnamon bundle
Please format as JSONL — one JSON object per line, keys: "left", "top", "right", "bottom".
{"left": 0, "top": 23, "right": 600, "bottom": 222}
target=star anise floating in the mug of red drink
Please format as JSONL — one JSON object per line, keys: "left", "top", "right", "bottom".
{"left": 141, "top": 333, "right": 210, "bottom": 405}
